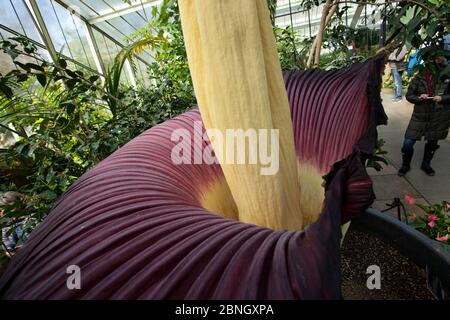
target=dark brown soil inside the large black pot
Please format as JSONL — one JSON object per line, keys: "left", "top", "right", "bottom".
{"left": 341, "top": 226, "right": 434, "bottom": 300}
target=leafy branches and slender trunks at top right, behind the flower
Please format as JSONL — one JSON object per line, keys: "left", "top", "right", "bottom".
{"left": 292, "top": 0, "right": 450, "bottom": 68}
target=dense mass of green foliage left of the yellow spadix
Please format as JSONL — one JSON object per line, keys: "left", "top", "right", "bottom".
{"left": 0, "top": 1, "right": 196, "bottom": 256}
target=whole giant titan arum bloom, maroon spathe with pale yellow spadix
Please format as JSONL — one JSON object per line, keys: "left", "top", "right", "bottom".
{"left": 0, "top": 0, "right": 386, "bottom": 299}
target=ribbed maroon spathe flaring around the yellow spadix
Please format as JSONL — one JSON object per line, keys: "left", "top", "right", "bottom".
{"left": 0, "top": 56, "right": 385, "bottom": 299}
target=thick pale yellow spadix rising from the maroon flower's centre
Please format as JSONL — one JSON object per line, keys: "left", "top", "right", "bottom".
{"left": 179, "top": 0, "right": 304, "bottom": 230}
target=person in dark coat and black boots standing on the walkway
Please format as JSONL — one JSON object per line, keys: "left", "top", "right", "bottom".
{"left": 398, "top": 50, "right": 450, "bottom": 176}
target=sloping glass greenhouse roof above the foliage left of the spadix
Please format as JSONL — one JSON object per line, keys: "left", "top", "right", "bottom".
{"left": 0, "top": 0, "right": 177, "bottom": 83}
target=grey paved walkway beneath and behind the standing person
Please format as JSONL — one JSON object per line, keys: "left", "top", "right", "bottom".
{"left": 369, "top": 89, "right": 450, "bottom": 215}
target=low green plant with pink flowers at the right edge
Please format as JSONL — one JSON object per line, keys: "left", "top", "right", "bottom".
{"left": 408, "top": 201, "right": 450, "bottom": 251}
